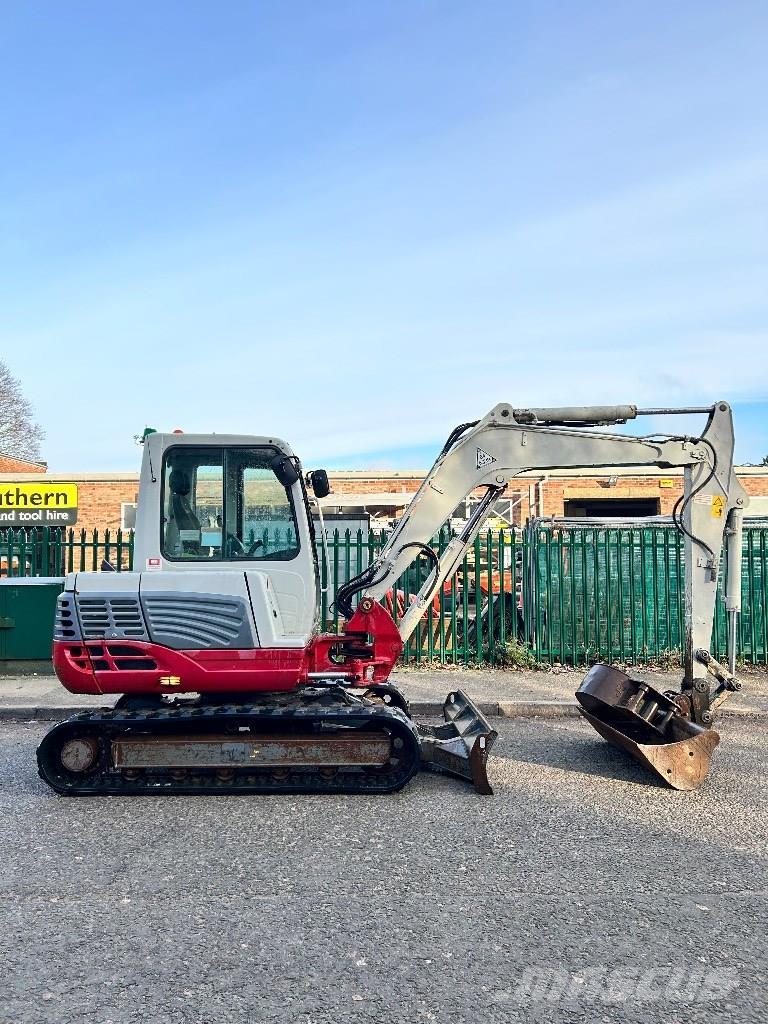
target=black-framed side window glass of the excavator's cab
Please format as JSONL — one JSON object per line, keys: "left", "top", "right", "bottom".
{"left": 162, "top": 445, "right": 299, "bottom": 561}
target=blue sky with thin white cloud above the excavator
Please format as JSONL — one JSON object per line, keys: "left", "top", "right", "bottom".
{"left": 0, "top": 0, "right": 768, "bottom": 472}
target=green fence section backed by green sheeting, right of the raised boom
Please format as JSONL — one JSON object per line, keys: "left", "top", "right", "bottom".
{"left": 527, "top": 524, "right": 768, "bottom": 665}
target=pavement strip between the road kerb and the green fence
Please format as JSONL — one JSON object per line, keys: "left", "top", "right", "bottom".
{"left": 0, "top": 668, "right": 768, "bottom": 722}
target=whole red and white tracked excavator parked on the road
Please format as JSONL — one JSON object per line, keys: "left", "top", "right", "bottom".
{"left": 38, "top": 402, "right": 746, "bottom": 795}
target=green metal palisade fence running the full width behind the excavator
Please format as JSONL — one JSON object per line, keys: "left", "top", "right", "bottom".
{"left": 0, "top": 522, "right": 768, "bottom": 665}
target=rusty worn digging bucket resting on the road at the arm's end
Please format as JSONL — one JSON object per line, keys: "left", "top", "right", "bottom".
{"left": 575, "top": 665, "right": 720, "bottom": 790}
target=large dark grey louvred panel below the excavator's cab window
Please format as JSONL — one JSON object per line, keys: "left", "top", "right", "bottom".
{"left": 141, "top": 592, "right": 255, "bottom": 650}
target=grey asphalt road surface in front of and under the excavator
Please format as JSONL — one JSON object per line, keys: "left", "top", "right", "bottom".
{"left": 0, "top": 719, "right": 768, "bottom": 1024}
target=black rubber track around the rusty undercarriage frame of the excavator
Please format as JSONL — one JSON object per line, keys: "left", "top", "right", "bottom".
{"left": 37, "top": 705, "right": 420, "bottom": 797}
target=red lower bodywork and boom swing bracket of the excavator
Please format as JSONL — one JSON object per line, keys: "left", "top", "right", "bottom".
{"left": 53, "top": 602, "right": 402, "bottom": 693}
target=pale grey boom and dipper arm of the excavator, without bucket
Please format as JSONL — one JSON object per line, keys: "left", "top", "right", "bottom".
{"left": 337, "top": 402, "right": 748, "bottom": 781}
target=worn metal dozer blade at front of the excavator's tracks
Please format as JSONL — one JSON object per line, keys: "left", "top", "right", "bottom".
{"left": 418, "top": 690, "right": 499, "bottom": 796}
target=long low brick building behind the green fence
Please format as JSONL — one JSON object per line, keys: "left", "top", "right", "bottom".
{"left": 0, "top": 457, "right": 768, "bottom": 530}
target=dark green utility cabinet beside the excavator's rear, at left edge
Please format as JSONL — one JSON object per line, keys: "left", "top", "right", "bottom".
{"left": 0, "top": 577, "right": 63, "bottom": 668}
